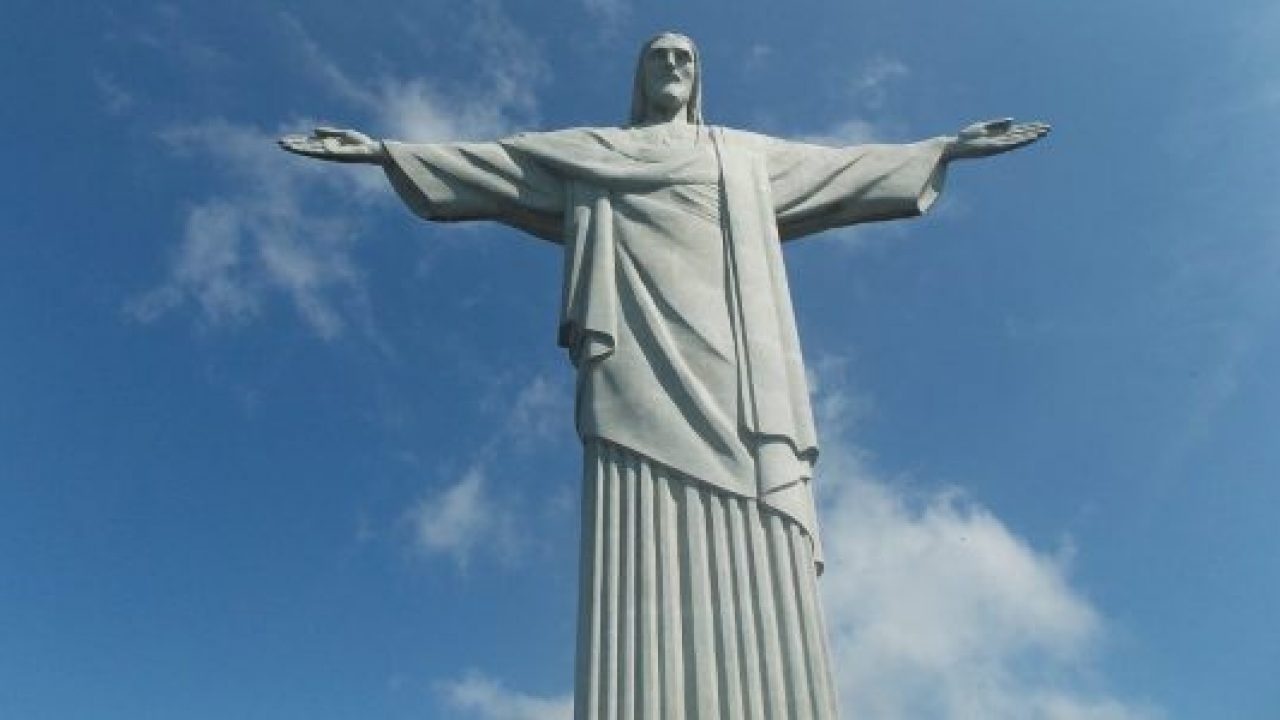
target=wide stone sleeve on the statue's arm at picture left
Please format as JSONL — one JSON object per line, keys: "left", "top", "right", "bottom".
{"left": 384, "top": 135, "right": 566, "bottom": 243}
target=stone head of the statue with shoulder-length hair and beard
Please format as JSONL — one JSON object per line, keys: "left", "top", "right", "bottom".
{"left": 630, "top": 32, "right": 703, "bottom": 126}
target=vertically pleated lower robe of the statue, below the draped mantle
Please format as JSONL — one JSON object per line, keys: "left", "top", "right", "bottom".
{"left": 575, "top": 441, "right": 837, "bottom": 720}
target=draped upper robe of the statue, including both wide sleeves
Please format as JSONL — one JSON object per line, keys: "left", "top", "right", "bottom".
{"left": 385, "top": 128, "right": 943, "bottom": 564}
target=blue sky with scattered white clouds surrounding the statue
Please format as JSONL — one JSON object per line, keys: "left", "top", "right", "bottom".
{"left": 0, "top": 0, "right": 1280, "bottom": 720}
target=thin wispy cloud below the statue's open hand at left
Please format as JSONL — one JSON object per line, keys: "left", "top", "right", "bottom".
{"left": 125, "top": 120, "right": 375, "bottom": 338}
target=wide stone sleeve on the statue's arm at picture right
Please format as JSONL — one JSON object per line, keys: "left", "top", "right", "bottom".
{"left": 763, "top": 138, "right": 946, "bottom": 240}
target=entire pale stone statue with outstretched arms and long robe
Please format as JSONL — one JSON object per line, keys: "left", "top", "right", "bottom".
{"left": 280, "top": 33, "right": 1048, "bottom": 720}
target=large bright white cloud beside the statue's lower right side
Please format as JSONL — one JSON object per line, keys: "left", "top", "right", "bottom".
{"left": 815, "top": 364, "right": 1160, "bottom": 720}
